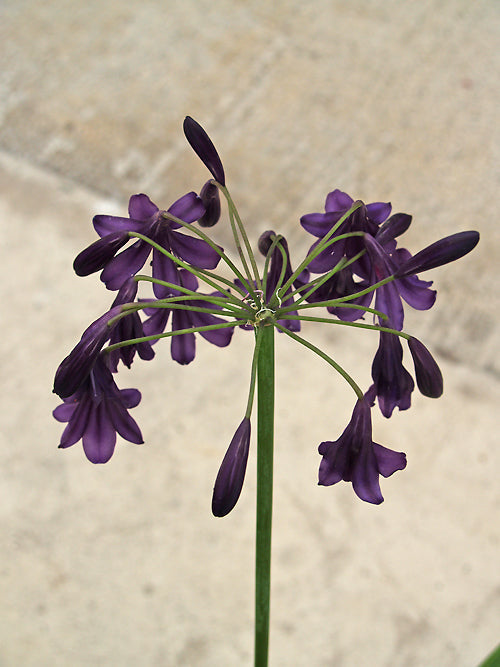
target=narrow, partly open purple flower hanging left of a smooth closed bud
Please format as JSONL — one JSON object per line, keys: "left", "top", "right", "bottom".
{"left": 372, "top": 331, "right": 415, "bottom": 417}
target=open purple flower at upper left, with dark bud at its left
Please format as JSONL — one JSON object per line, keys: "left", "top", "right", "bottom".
{"left": 74, "top": 192, "right": 220, "bottom": 298}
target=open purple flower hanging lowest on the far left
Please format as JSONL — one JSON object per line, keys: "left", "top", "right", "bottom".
{"left": 53, "top": 357, "right": 143, "bottom": 463}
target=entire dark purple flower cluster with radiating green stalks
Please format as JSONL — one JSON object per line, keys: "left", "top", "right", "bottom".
{"left": 54, "top": 117, "right": 479, "bottom": 516}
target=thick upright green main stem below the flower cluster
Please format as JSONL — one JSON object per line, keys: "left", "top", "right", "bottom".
{"left": 254, "top": 323, "right": 274, "bottom": 667}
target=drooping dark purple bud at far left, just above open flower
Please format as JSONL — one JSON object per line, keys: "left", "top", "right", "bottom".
{"left": 54, "top": 306, "right": 121, "bottom": 398}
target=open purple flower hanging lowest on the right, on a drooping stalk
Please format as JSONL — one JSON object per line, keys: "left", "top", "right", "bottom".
{"left": 319, "top": 387, "right": 406, "bottom": 505}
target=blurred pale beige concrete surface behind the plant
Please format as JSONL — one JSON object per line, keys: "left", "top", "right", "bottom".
{"left": 0, "top": 0, "right": 500, "bottom": 667}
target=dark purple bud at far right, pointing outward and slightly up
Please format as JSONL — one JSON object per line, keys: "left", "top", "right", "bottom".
{"left": 395, "top": 231, "right": 479, "bottom": 278}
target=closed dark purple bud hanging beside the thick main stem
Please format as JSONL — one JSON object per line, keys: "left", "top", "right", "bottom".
{"left": 212, "top": 417, "right": 250, "bottom": 517}
